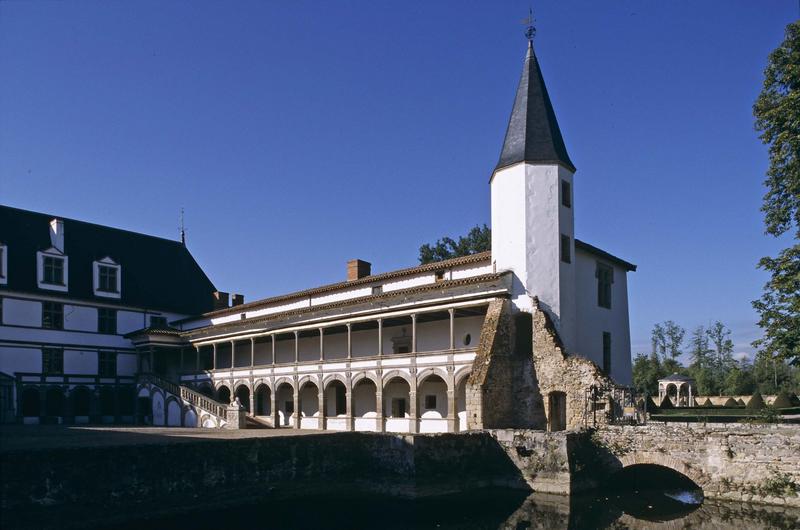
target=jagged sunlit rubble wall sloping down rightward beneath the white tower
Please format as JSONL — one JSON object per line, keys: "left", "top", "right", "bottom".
{"left": 532, "top": 298, "right": 614, "bottom": 429}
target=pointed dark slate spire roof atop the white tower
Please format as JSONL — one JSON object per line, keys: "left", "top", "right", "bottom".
{"left": 495, "top": 40, "right": 575, "bottom": 172}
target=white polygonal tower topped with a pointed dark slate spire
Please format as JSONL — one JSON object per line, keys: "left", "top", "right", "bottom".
{"left": 490, "top": 42, "right": 577, "bottom": 352}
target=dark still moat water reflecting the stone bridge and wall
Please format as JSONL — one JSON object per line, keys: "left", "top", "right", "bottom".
{"left": 72, "top": 490, "right": 800, "bottom": 530}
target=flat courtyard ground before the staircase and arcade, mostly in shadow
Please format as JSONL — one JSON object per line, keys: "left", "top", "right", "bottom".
{"left": 0, "top": 425, "right": 335, "bottom": 452}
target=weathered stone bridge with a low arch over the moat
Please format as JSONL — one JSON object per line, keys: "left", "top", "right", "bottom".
{"left": 588, "top": 423, "right": 800, "bottom": 507}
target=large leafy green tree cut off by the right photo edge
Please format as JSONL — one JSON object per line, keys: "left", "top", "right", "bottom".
{"left": 753, "top": 21, "right": 800, "bottom": 364}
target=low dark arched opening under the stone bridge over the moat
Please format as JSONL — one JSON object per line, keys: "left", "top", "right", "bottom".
{"left": 605, "top": 464, "right": 703, "bottom": 521}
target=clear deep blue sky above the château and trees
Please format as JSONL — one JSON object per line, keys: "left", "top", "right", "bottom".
{"left": 0, "top": 0, "right": 800, "bottom": 353}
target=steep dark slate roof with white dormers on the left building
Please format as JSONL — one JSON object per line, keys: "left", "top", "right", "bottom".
{"left": 0, "top": 205, "right": 216, "bottom": 314}
